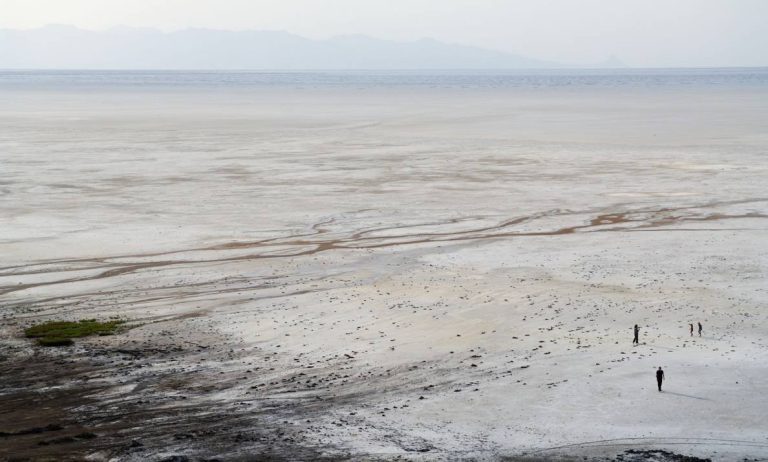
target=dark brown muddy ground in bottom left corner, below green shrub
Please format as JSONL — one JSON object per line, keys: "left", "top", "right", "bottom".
{"left": 0, "top": 332, "right": 343, "bottom": 461}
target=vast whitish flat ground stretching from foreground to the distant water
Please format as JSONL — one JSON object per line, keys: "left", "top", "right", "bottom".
{"left": 0, "top": 79, "right": 768, "bottom": 460}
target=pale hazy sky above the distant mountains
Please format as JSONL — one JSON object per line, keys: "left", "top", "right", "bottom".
{"left": 0, "top": 0, "right": 768, "bottom": 67}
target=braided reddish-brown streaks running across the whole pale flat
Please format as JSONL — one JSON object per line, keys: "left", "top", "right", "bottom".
{"left": 0, "top": 199, "right": 768, "bottom": 295}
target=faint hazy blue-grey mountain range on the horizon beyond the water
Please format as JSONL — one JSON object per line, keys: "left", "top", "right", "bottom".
{"left": 0, "top": 25, "right": 608, "bottom": 70}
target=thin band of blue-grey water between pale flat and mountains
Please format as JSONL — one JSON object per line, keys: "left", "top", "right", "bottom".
{"left": 0, "top": 68, "right": 768, "bottom": 91}
